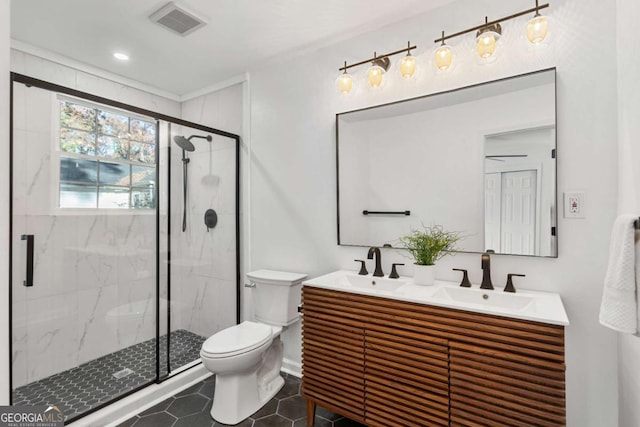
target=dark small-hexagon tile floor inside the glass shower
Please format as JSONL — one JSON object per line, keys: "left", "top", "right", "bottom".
{"left": 12, "top": 329, "right": 206, "bottom": 422}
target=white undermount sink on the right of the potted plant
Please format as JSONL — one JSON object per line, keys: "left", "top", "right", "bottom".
{"left": 432, "top": 287, "right": 533, "bottom": 311}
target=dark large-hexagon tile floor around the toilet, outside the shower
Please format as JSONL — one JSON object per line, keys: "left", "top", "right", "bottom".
{"left": 118, "top": 374, "right": 364, "bottom": 427}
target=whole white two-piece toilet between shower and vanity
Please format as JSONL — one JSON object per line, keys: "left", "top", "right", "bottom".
{"left": 200, "top": 270, "right": 307, "bottom": 424}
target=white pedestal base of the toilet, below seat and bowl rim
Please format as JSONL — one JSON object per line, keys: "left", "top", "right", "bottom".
{"left": 211, "top": 337, "right": 284, "bottom": 425}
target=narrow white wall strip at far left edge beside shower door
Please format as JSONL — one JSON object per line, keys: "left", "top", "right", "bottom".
{"left": 0, "top": 2, "right": 11, "bottom": 405}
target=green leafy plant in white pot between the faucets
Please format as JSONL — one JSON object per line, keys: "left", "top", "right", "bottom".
{"left": 399, "top": 225, "right": 461, "bottom": 285}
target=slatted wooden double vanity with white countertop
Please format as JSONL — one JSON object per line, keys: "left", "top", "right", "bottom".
{"left": 302, "top": 271, "right": 568, "bottom": 427}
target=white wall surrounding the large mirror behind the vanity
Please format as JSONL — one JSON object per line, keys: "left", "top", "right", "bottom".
{"left": 251, "top": 0, "right": 630, "bottom": 427}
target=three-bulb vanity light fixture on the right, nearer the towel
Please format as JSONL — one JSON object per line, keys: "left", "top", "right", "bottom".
{"left": 434, "top": 0, "right": 549, "bottom": 70}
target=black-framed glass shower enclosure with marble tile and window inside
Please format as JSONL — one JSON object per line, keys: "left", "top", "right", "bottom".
{"left": 10, "top": 74, "right": 240, "bottom": 422}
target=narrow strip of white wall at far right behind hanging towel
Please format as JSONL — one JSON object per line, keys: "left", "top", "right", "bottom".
{"left": 617, "top": 0, "right": 640, "bottom": 427}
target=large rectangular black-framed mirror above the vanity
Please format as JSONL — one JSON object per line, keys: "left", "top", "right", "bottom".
{"left": 336, "top": 69, "right": 557, "bottom": 257}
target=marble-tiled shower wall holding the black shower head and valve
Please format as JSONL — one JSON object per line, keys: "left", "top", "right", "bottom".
{"left": 171, "top": 132, "right": 236, "bottom": 337}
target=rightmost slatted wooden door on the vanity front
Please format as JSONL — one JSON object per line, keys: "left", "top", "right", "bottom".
{"left": 450, "top": 342, "right": 566, "bottom": 427}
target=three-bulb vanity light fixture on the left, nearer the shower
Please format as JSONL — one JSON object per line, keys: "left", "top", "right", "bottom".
{"left": 337, "top": 42, "right": 417, "bottom": 94}
